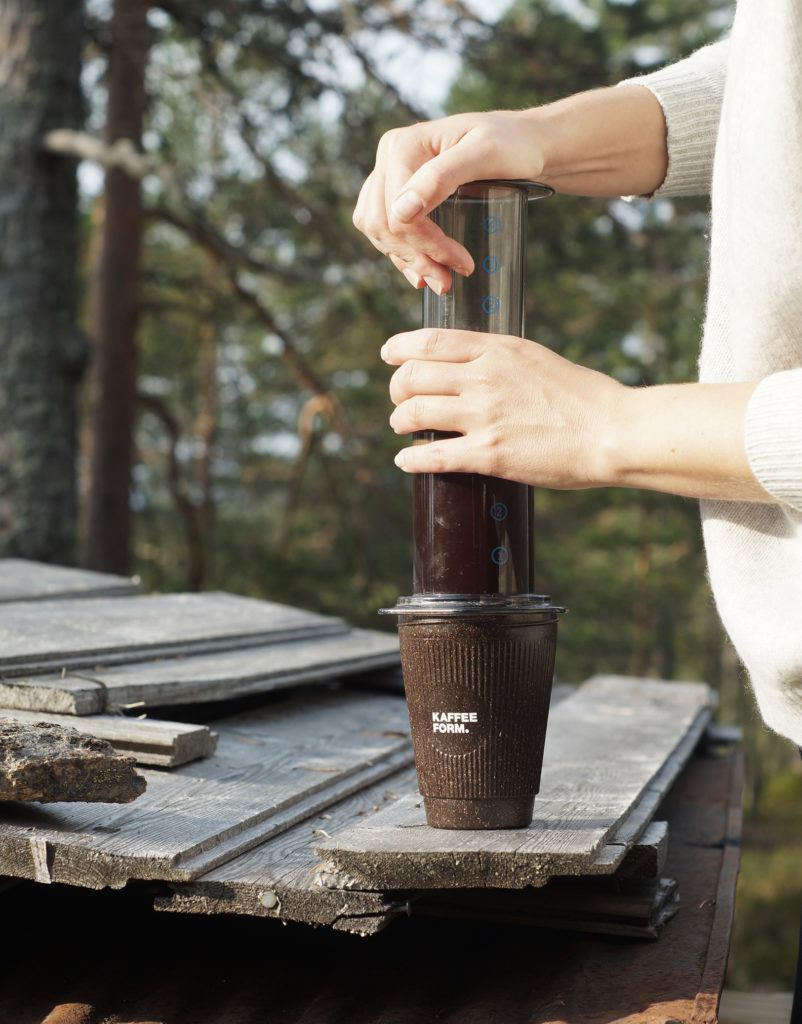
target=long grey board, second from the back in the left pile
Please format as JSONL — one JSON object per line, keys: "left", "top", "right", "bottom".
{"left": 0, "top": 593, "right": 346, "bottom": 677}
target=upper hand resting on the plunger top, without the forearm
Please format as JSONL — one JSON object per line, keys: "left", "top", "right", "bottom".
{"left": 353, "top": 111, "right": 544, "bottom": 295}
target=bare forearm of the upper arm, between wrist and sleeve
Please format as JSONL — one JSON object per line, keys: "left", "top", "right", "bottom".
{"left": 524, "top": 85, "right": 668, "bottom": 196}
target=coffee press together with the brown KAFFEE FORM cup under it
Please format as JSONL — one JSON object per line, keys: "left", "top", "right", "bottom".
{"left": 382, "top": 181, "right": 564, "bottom": 828}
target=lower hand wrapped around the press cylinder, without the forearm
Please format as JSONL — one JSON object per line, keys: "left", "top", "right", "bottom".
{"left": 381, "top": 329, "right": 631, "bottom": 488}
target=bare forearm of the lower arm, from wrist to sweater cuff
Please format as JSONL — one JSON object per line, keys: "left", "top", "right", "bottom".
{"left": 599, "top": 382, "right": 773, "bottom": 502}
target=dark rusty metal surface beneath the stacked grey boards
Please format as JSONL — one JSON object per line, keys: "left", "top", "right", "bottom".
{"left": 0, "top": 754, "right": 743, "bottom": 1024}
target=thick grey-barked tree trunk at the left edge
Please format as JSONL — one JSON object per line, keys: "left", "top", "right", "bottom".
{"left": 0, "top": 0, "right": 85, "bottom": 563}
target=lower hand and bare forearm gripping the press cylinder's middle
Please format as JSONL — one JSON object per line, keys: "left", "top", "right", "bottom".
{"left": 381, "top": 329, "right": 773, "bottom": 502}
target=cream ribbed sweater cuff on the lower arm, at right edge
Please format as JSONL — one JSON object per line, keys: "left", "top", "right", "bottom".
{"left": 745, "top": 368, "right": 802, "bottom": 512}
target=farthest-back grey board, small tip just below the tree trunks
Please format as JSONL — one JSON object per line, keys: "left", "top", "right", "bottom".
{"left": 0, "top": 558, "right": 139, "bottom": 603}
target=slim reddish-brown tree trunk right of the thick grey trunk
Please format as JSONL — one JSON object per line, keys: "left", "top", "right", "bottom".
{"left": 84, "top": 0, "right": 150, "bottom": 572}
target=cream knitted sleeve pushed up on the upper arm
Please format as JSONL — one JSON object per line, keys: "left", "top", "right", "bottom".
{"left": 619, "top": 39, "right": 729, "bottom": 196}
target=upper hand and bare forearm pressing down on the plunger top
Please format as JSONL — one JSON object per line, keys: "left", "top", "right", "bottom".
{"left": 353, "top": 85, "right": 668, "bottom": 294}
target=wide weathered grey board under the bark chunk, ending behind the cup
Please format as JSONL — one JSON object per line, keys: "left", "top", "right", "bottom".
{"left": 0, "top": 692, "right": 412, "bottom": 888}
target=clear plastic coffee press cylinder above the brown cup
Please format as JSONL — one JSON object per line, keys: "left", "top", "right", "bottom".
{"left": 413, "top": 181, "right": 551, "bottom": 596}
